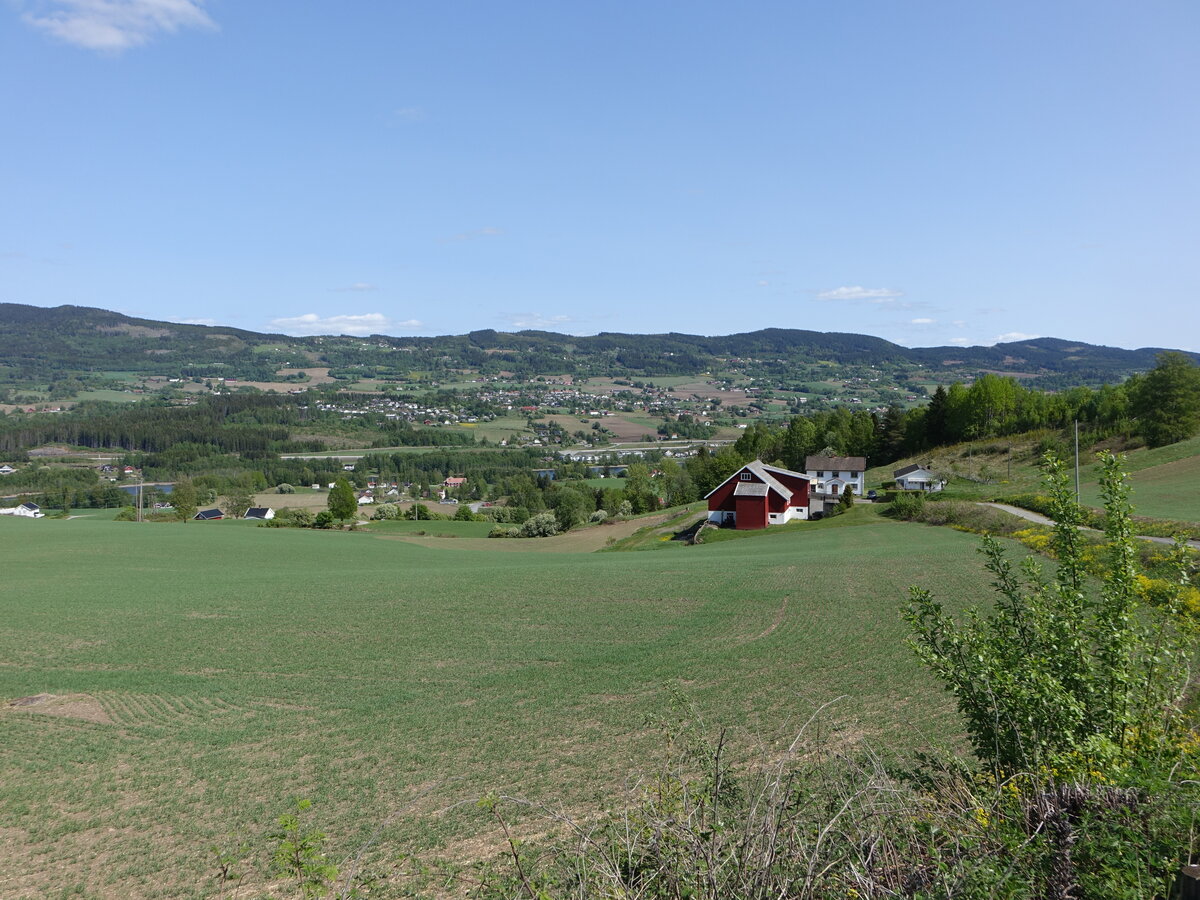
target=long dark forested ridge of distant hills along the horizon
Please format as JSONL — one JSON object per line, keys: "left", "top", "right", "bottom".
{"left": 0, "top": 304, "right": 1200, "bottom": 386}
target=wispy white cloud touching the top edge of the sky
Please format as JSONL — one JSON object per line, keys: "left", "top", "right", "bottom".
{"left": 22, "top": 0, "right": 216, "bottom": 53}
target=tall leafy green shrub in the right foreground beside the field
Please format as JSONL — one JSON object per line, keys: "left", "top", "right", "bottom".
{"left": 906, "top": 454, "right": 1190, "bottom": 779}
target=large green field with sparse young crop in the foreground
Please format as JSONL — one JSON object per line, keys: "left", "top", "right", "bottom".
{"left": 0, "top": 514, "right": 1012, "bottom": 898}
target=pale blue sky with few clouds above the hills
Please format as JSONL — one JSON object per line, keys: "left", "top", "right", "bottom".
{"left": 0, "top": 0, "right": 1200, "bottom": 349}
